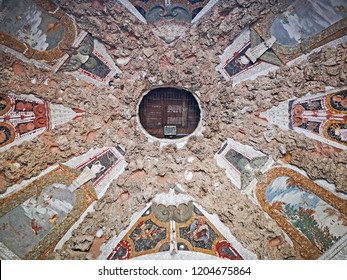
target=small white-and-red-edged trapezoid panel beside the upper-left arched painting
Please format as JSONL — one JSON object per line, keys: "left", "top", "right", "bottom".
{"left": 59, "top": 35, "right": 121, "bottom": 85}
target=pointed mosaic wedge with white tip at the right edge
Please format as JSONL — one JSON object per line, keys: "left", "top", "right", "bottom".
{"left": 260, "top": 89, "right": 347, "bottom": 149}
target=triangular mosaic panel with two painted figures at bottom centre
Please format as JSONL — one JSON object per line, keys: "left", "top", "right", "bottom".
{"left": 101, "top": 189, "right": 253, "bottom": 260}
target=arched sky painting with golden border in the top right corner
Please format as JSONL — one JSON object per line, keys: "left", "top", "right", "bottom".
{"left": 252, "top": 0, "right": 347, "bottom": 63}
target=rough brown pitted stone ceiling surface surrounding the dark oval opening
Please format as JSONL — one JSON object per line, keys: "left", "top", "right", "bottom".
{"left": 0, "top": 0, "right": 347, "bottom": 259}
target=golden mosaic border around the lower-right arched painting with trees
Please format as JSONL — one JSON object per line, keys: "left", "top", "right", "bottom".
{"left": 256, "top": 167, "right": 347, "bottom": 259}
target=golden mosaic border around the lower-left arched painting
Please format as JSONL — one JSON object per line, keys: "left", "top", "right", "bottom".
{"left": 0, "top": 165, "right": 97, "bottom": 260}
